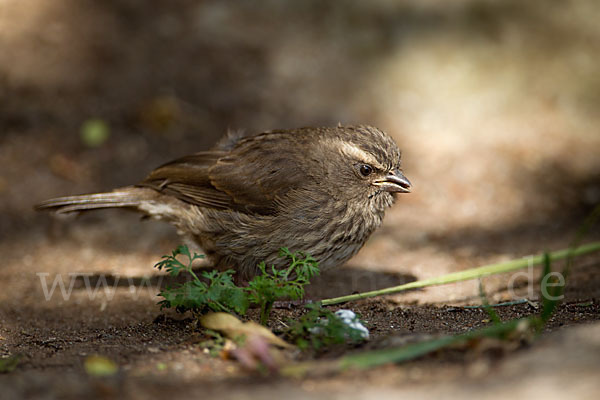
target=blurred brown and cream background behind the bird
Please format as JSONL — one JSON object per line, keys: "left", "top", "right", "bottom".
{"left": 0, "top": 0, "right": 600, "bottom": 300}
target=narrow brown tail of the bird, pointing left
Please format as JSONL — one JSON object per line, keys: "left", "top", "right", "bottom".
{"left": 35, "top": 186, "right": 148, "bottom": 214}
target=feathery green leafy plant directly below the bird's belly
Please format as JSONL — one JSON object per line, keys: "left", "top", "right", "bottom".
{"left": 155, "top": 245, "right": 319, "bottom": 325}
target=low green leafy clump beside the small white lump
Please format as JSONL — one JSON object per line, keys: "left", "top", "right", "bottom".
{"left": 287, "top": 303, "right": 365, "bottom": 350}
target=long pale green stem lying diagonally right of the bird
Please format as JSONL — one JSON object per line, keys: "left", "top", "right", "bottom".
{"left": 321, "top": 242, "right": 600, "bottom": 306}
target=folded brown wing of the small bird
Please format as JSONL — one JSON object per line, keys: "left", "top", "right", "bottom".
{"left": 140, "top": 134, "right": 304, "bottom": 214}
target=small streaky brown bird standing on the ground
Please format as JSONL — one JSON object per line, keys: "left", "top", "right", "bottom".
{"left": 36, "top": 126, "right": 411, "bottom": 277}
